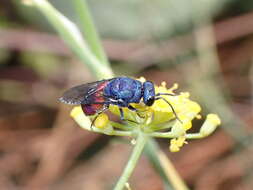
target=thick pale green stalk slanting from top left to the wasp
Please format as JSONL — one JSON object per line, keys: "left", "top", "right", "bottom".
{"left": 32, "top": 0, "right": 113, "bottom": 79}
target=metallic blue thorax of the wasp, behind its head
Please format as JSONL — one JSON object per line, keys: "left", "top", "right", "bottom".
{"left": 104, "top": 77, "right": 143, "bottom": 107}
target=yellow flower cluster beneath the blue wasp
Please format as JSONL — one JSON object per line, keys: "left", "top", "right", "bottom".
{"left": 71, "top": 78, "right": 221, "bottom": 152}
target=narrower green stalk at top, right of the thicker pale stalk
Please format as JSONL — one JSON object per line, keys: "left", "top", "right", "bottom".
{"left": 72, "top": 0, "right": 109, "bottom": 66}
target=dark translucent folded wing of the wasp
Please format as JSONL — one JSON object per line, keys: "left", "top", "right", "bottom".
{"left": 59, "top": 80, "right": 109, "bottom": 105}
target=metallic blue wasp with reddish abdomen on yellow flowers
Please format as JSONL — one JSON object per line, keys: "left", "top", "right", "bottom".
{"left": 59, "top": 77, "right": 181, "bottom": 125}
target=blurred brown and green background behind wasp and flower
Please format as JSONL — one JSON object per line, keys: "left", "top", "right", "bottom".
{"left": 0, "top": 0, "right": 253, "bottom": 190}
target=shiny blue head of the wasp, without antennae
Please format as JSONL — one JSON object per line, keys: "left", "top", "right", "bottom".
{"left": 143, "top": 81, "right": 155, "bottom": 106}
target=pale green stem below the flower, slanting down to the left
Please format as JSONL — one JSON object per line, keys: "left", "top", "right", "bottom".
{"left": 114, "top": 131, "right": 148, "bottom": 190}
